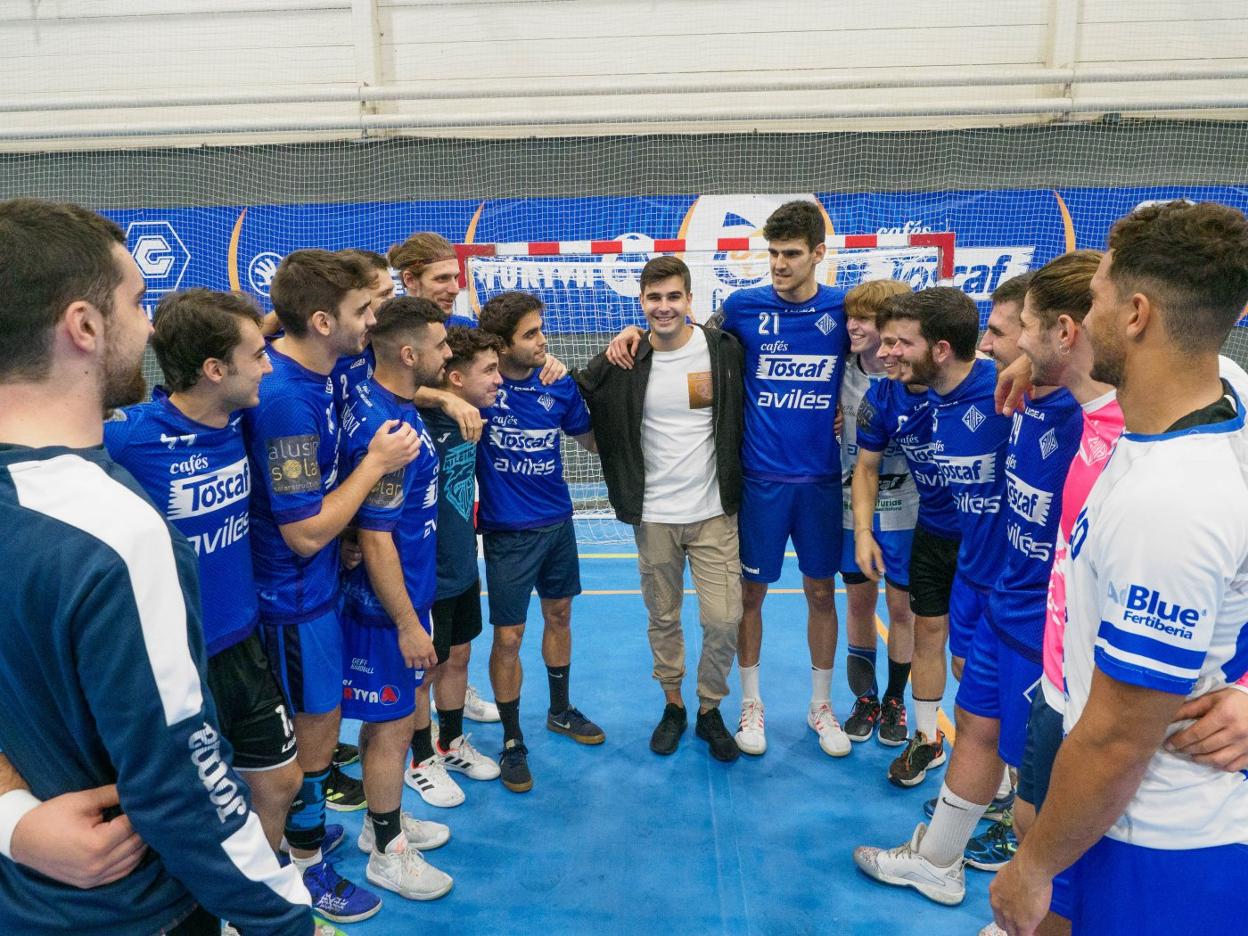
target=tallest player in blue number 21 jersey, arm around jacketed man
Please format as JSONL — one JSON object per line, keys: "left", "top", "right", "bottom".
{"left": 608, "top": 201, "right": 850, "bottom": 758}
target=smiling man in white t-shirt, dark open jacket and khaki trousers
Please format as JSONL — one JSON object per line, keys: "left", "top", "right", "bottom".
{"left": 575, "top": 257, "right": 744, "bottom": 761}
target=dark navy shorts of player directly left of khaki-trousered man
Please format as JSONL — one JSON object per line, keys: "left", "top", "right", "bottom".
{"left": 482, "top": 520, "right": 580, "bottom": 628}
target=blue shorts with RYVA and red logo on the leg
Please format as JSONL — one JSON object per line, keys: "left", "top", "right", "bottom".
{"left": 339, "top": 605, "right": 433, "bottom": 721}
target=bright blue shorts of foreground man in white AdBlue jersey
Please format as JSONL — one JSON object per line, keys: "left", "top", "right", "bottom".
{"left": 1071, "top": 836, "right": 1248, "bottom": 936}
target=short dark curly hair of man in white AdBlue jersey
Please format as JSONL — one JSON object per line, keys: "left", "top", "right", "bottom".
{"left": 1109, "top": 201, "right": 1248, "bottom": 353}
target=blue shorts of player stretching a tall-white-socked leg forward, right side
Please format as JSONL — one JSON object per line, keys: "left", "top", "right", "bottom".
{"left": 957, "top": 618, "right": 1043, "bottom": 768}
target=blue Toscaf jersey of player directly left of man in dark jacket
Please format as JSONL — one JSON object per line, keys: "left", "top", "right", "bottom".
{"left": 477, "top": 371, "right": 589, "bottom": 530}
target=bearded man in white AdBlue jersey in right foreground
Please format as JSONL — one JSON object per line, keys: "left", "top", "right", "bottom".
{"left": 991, "top": 202, "right": 1248, "bottom": 934}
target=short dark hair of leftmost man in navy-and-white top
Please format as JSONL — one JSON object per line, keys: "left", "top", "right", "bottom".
{"left": 0, "top": 198, "right": 126, "bottom": 383}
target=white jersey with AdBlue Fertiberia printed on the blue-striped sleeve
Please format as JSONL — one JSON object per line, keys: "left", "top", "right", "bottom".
{"left": 1065, "top": 366, "right": 1248, "bottom": 850}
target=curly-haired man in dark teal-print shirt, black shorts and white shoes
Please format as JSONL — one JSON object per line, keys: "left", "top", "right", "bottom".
{"left": 404, "top": 326, "right": 503, "bottom": 806}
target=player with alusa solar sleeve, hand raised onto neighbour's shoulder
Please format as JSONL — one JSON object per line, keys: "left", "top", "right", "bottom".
{"left": 243, "top": 250, "right": 419, "bottom": 922}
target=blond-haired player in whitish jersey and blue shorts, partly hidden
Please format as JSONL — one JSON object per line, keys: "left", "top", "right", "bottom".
{"left": 841, "top": 280, "right": 919, "bottom": 746}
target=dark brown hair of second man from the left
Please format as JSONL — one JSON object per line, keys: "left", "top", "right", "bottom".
{"left": 152, "top": 288, "right": 261, "bottom": 393}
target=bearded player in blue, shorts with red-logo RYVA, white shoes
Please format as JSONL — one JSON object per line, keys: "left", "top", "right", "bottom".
{"left": 342, "top": 296, "right": 452, "bottom": 900}
